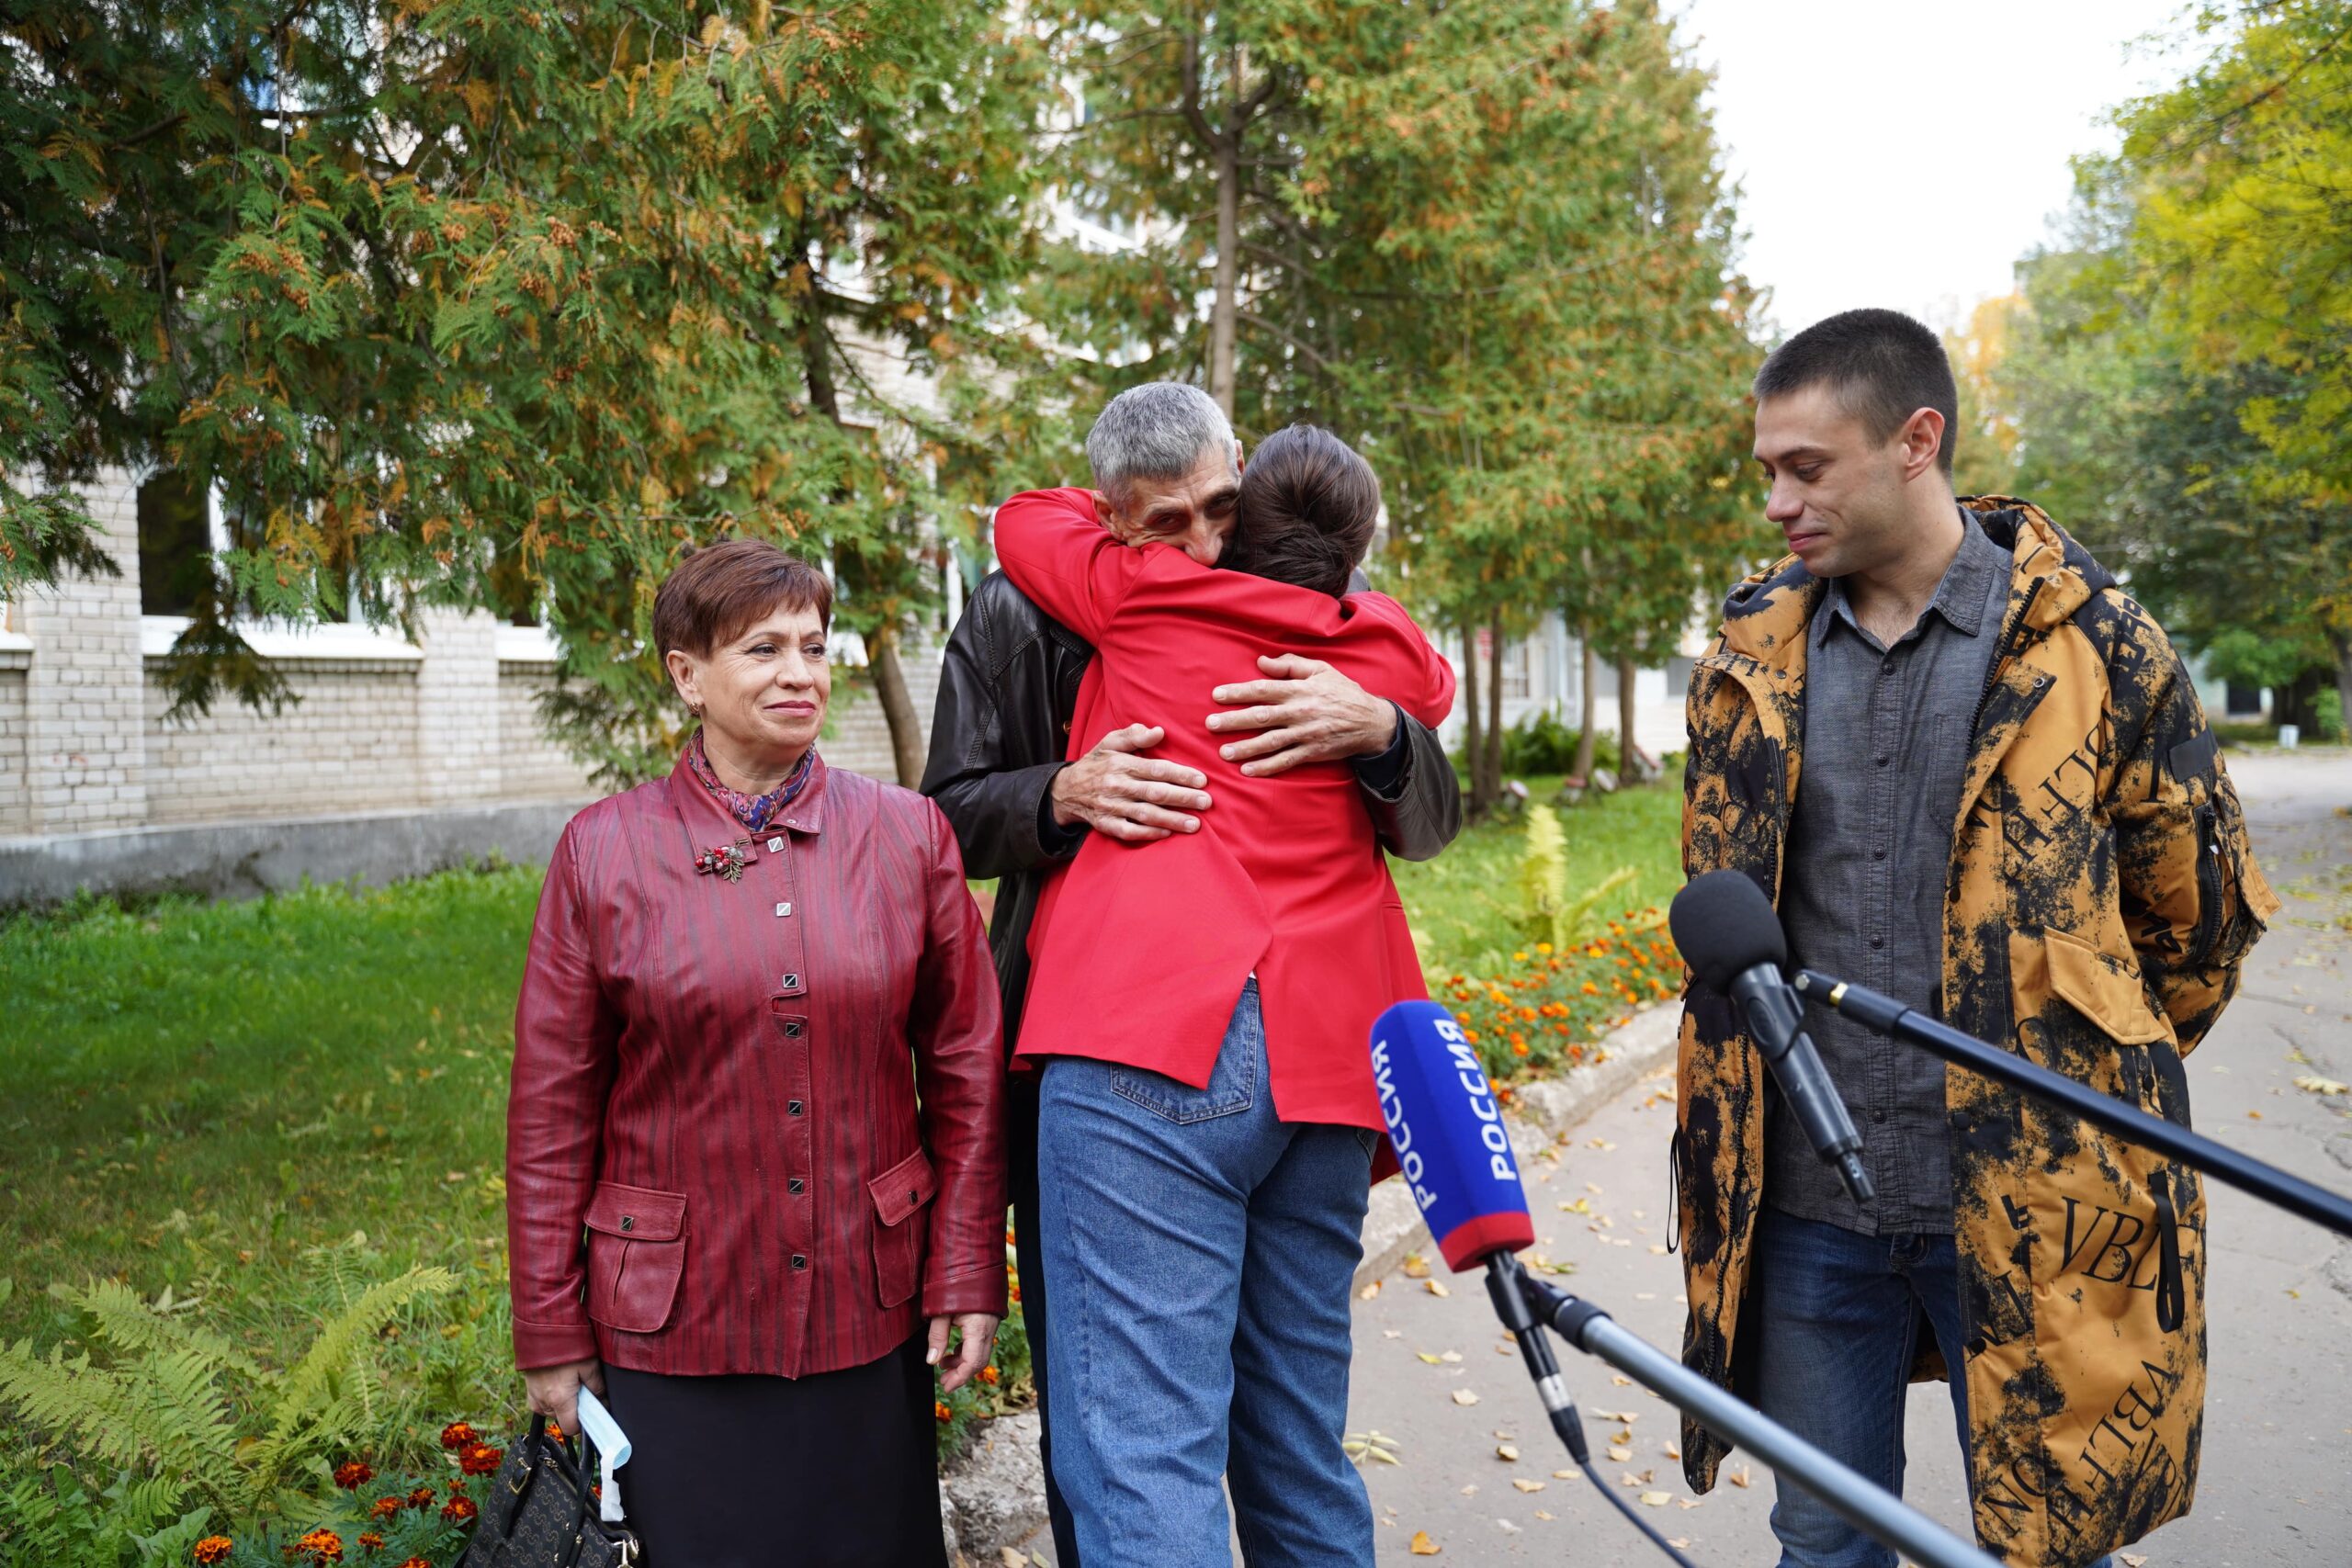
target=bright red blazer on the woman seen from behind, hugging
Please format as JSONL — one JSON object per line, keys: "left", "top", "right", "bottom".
{"left": 995, "top": 489, "right": 1453, "bottom": 1128}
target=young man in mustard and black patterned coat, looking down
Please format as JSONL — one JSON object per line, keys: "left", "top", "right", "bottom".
{"left": 1672, "top": 310, "right": 2277, "bottom": 1568}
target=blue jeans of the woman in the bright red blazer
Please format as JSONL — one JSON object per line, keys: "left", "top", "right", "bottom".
{"left": 1037, "top": 980, "right": 1376, "bottom": 1568}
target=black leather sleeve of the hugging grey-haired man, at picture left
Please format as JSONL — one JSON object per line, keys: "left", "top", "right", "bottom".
{"left": 922, "top": 594, "right": 1084, "bottom": 882}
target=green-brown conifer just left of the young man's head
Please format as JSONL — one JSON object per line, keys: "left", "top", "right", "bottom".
{"left": 1298, "top": 0, "right": 1755, "bottom": 804}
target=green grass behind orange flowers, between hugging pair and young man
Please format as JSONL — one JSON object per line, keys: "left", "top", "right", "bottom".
{"left": 1390, "top": 771, "right": 1681, "bottom": 985}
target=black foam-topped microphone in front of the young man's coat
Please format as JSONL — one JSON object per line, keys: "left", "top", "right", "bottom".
{"left": 1665, "top": 872, "right": 1877, "bottom": 1203}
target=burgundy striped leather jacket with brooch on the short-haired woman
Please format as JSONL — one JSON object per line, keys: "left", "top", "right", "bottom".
{"left": 505, "top": 757, "right": 1004, "bottom": 1378}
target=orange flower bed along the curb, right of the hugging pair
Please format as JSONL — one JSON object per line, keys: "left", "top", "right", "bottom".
{"left": 1437, "top": 909, "right": 1681, "bottom": 1093}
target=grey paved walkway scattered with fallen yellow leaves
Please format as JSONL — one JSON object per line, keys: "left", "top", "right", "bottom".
{"left": 1348, "top": 750, "right": 2352, "bottom": 1568}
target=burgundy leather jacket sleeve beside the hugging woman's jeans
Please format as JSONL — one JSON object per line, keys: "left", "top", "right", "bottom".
{"left": 908, "top": 811, "right": 1007, "bottom": 1316}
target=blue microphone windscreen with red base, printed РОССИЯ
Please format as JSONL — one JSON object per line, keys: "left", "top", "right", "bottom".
{"left": 1371, "top": 1001, "right": 1536, "bottom": 1274}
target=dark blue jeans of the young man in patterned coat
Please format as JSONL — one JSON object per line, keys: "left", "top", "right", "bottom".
{"left": 1750, "top": 1208, "right": 2112, "bottom": 1568}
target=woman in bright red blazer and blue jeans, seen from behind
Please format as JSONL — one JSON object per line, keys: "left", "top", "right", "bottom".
{"left": 995, "top": 421, "right": 1453, "bottom": 1568}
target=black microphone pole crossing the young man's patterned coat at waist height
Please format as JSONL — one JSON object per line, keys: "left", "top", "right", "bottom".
{"left": 1797, "top": 968, "right": 2352, "bottom": 1236}
